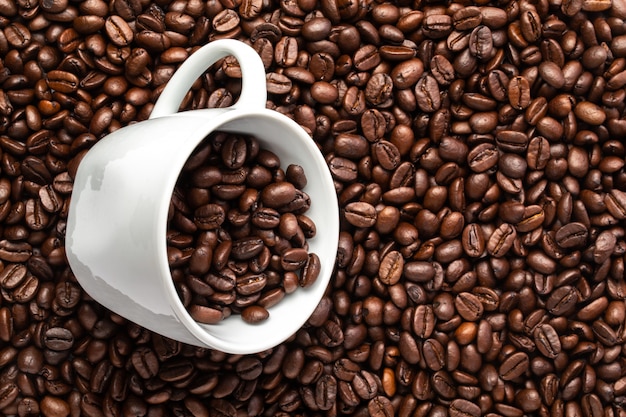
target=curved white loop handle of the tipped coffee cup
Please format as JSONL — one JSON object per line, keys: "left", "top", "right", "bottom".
{"left": 149, "top": 39, "right": 267, "bottom": 119}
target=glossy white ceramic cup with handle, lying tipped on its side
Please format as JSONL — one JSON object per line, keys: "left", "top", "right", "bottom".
{"left": 65, "top": 40, "right": 339, "bottom": 354}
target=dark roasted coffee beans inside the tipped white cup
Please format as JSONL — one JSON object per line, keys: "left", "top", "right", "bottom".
{"left": 167, "top": 132, "right": 321, "bottom": 324}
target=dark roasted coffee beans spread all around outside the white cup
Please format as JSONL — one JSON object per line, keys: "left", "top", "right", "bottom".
{"left": 0, "top": 0, "right": 626, "bottom": 417}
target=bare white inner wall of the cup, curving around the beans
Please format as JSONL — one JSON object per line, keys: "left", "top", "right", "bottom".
{"left": 166, "top": 110, "right": 339, "bottom": 353}
